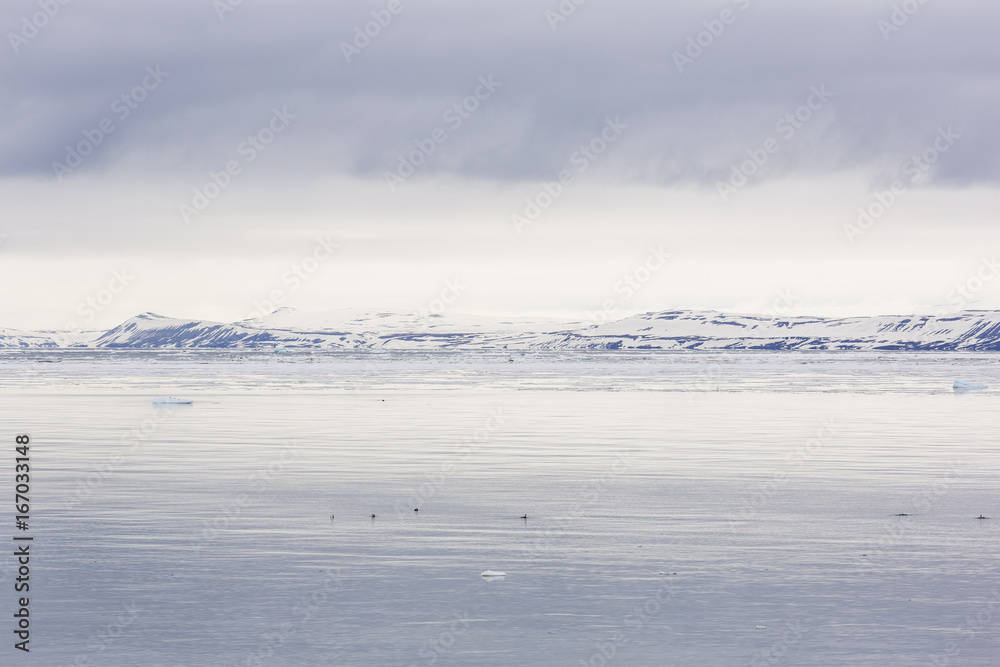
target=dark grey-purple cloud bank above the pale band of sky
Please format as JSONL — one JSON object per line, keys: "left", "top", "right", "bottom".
{"left": 0, "top": 0, "right": 1000, "bottom": 185}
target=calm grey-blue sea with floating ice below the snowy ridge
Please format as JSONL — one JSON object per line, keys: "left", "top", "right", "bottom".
{"left": 0, "top": 349, "right": 1000, "bottom": 667}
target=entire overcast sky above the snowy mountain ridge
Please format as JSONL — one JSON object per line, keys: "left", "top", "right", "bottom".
{"left": 0, "top": 0, "right": 1000, "bottom": 329}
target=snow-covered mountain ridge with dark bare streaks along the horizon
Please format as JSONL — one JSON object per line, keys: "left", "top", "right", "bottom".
{"left": 0, "top": 309, "right": 1000, "bottom": 351}
